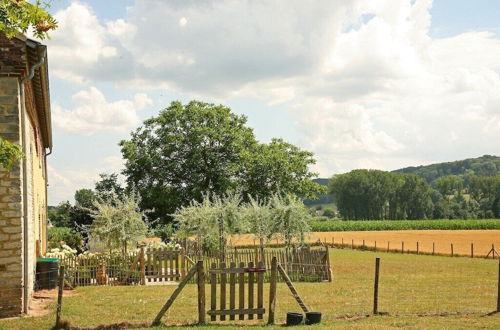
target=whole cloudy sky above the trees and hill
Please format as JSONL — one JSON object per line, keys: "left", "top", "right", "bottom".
{"left": 43, "top": 0, "right": 500, "bottom": 205}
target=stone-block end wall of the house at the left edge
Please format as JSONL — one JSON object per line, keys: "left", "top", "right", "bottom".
{"left": 0, "top": 77, "right": 23, "bottom": 318}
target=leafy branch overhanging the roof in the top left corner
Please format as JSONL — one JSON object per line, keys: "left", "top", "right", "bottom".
{"left": 0, "top": 0, "right": 57, "bottom": 39}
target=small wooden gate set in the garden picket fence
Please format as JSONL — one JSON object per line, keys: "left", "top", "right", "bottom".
{"left": 145, "top": 248, "right": 184, "bottom": 283}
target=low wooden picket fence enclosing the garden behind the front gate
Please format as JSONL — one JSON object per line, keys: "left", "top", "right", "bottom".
{"left": 56, "top": 246, "right": 332, "bottom": 286}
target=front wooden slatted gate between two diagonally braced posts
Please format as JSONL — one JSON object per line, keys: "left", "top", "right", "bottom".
{"left": 207, "top": 262, "right": 266, "bottom": 321}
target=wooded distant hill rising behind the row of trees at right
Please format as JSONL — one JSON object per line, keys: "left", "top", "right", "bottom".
{"left": 393, "top": 155, "right": 500, "bottom": 183}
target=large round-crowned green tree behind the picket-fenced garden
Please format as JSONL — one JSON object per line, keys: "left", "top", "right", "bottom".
{"left": 120, "top": 101, "right": 321, "bottom": 222}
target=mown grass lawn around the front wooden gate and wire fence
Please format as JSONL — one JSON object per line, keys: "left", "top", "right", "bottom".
{"left": 0, "top": 250, "right": 500, "bottom": 329}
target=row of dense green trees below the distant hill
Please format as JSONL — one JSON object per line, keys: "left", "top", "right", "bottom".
{"left": 329, "top": 170, "right": 500, "bottom": 220}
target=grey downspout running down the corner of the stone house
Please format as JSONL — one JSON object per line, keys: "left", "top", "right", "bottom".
{"left": 20, "top": 48, "right": 47, "bottom": 313}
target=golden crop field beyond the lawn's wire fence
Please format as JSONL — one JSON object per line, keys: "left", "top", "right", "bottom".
{"left": 231, "top": 230, "right": 500, "bottom": 258}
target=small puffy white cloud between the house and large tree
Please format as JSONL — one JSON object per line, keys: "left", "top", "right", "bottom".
{"left": 52, "top": 87, "right": 152, "bottom": 135}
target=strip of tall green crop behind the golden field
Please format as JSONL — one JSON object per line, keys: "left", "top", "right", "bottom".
{"left": 309, "top": 219, "right": 500, "bottom": 232}
